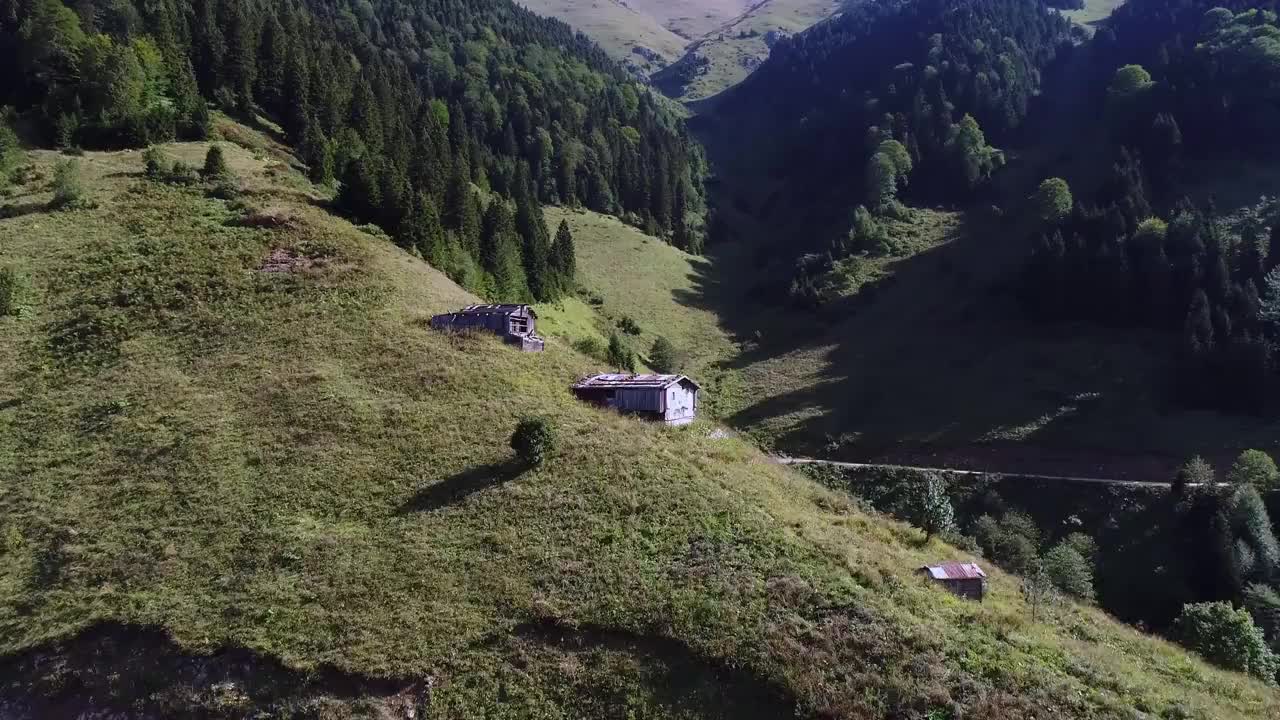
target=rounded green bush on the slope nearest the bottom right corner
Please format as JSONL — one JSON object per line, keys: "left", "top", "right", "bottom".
{"left": 1174, "top": 602, "right": 1277, "bottom": 683}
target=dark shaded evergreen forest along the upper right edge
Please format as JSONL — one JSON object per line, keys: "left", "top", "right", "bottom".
{"left": 1025, "top": 0, "right": 1280, "bottom": 413}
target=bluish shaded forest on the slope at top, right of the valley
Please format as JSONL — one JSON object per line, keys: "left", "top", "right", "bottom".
{"left": 719, "top": 0, "right": 1069, "bottom": 297}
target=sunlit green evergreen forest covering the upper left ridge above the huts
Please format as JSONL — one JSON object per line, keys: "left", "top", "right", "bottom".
{"left": 0, "top": 0, "right": 705, "bottom": 301}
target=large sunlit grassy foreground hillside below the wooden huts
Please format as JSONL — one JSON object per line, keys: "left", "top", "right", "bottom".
{"left": 0, "top": 133, "right": 1280, "bottom": 719}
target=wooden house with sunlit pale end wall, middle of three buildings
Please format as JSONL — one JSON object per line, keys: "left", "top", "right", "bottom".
{"left": 573, "top": 374, "right": 701, "bottom": 425}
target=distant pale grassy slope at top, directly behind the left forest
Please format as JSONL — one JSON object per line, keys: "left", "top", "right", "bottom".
{"left": 520, "top": 0, "right": 687, "bottom": 73}
